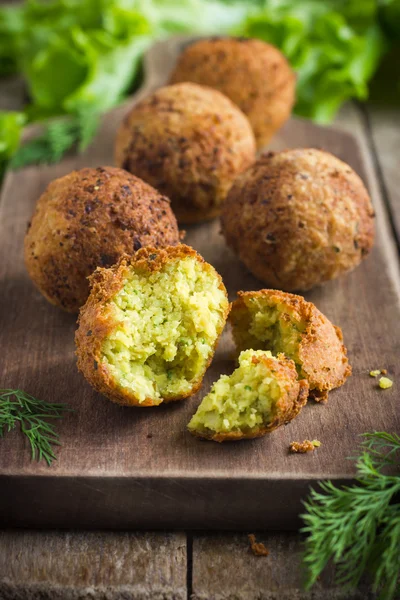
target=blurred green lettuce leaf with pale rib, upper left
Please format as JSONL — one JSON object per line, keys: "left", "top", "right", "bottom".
{"left": 20, "top": 0, "right": 151, "bottom": 118}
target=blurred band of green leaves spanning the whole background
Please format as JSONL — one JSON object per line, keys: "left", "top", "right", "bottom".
{"left": 0, "top": 0, "right": 400, "bottom": 176}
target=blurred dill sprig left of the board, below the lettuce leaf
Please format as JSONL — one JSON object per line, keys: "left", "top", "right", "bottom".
{"left": 10, "top": 110, "right": 100, "bottom": 169}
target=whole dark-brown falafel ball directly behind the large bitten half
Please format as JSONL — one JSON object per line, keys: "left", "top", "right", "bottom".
{"left": 25, "top": 167, "right": 179, "bottom": 312}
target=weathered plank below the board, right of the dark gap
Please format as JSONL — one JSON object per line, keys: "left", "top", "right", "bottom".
{"left": 192, "top": 533, "right": 377, "bottom": 600}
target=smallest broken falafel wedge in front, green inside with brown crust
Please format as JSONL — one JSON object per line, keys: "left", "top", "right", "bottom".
{"left": 188, "top": 350, "right": 308, "bottom": 442}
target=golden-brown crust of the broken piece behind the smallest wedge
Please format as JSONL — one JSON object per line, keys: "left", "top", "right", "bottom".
{"left": 229, "top": 290, "right": 351, "bottom": 402}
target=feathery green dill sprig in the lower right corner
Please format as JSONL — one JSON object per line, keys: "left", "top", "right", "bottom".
{"left": 302, "top": 432, "right": 400, "bottom": 600}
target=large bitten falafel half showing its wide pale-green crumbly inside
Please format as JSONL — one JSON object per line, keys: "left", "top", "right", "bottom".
{"left": 75, "top": 245, "right": 229, "bottom": 406}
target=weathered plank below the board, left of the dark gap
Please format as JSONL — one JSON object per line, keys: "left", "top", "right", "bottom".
{"left": 0, "top": 531, "right": 187, "bottom": 600}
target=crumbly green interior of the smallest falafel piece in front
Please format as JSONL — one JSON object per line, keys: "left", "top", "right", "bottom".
{"left": 188, "top": 350, "right": 290, "bottom": 441}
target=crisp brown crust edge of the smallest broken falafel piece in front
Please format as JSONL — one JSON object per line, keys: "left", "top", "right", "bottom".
{"left": 190, "top": 354, "right": 309, "bottom": 442}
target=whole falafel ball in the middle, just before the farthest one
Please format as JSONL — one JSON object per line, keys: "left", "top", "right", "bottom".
{"left": 115, "top": 83, "right": 255, "bottom": 223}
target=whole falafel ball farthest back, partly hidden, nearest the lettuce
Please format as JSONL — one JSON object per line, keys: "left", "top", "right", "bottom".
{"left": 171, "top": 38, "right": 296, "bottom": 148}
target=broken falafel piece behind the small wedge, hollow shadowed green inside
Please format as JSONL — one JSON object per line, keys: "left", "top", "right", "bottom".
{"left": 229, "top": 290, "right": 351, "bottom": 401}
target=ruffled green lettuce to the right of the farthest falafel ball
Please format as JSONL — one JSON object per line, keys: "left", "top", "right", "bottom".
{"left": 240, "top": 0, "right": 386, "bottom": 123}
